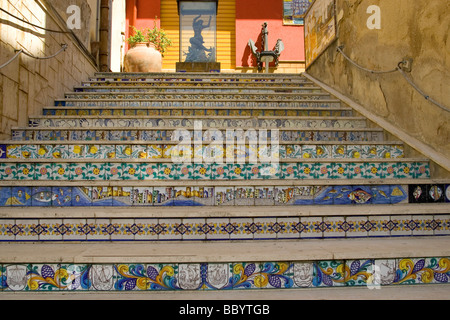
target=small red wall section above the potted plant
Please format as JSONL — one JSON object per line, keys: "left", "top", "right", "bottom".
{"left": 125, "top": 0, "right": 161, "bottom": 49}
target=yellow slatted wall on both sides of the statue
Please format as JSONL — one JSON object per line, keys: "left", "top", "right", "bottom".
{"left": 161, "top": 0, "right": 236, "bottom": 71}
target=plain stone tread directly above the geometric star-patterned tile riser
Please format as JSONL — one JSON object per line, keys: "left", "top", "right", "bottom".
{"left": 0, "top": 202, "right": 450, "bottom": 220}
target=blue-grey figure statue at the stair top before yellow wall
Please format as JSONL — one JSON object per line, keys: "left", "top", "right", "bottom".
{"left": 186, "top": 15, "right": 214, "bottom": 62}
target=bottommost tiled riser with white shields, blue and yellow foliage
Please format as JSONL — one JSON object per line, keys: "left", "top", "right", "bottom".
{"left": 0, "top": 257, "right": 450, "bottom": 292}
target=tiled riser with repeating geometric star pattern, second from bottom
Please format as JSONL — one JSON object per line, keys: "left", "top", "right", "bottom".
{"left": 0, "top": 214, "right": 450, "bottom": 242}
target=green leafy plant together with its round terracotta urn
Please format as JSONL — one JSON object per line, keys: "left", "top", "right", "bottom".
{"left": 124, "top": 21, "right": 172, "bottom": 72}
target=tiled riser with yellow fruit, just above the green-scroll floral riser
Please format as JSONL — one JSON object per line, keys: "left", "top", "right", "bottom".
{"left": 0, "top": 144, "right": 404, "bottom": 161}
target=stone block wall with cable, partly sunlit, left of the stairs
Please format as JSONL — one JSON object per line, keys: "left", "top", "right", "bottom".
{"left": 0, "top": 0, "right": 97, "bottom": 139}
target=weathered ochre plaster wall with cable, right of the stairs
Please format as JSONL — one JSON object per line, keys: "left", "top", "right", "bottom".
{"left": 307, "top": 0, "right": 450, "bottom": 159}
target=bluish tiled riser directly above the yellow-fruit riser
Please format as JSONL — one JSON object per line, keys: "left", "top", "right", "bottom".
{"left": 12, "top": 128, "right": 384, "bottom": 142}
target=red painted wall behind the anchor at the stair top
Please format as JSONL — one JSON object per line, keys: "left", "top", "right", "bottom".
{"left": 236, "top": 0, "right": 305, "bottom": 67}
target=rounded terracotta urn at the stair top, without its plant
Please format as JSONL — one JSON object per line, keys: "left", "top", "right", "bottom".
{"left": 124, "top": 43, "right": 162, "bottom": 72}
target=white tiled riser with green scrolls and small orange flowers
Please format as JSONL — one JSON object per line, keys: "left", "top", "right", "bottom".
{"left": 0, "top": 160, "right": 430, "bottom": 181}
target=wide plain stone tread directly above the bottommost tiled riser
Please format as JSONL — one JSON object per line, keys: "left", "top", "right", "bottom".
{"left": 0, "top": 237, "right": 450, "bottom": 264}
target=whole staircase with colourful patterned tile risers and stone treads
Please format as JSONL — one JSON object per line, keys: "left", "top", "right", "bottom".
{"left": 0, "top": 73, "right": 450, "bottom": 293}
